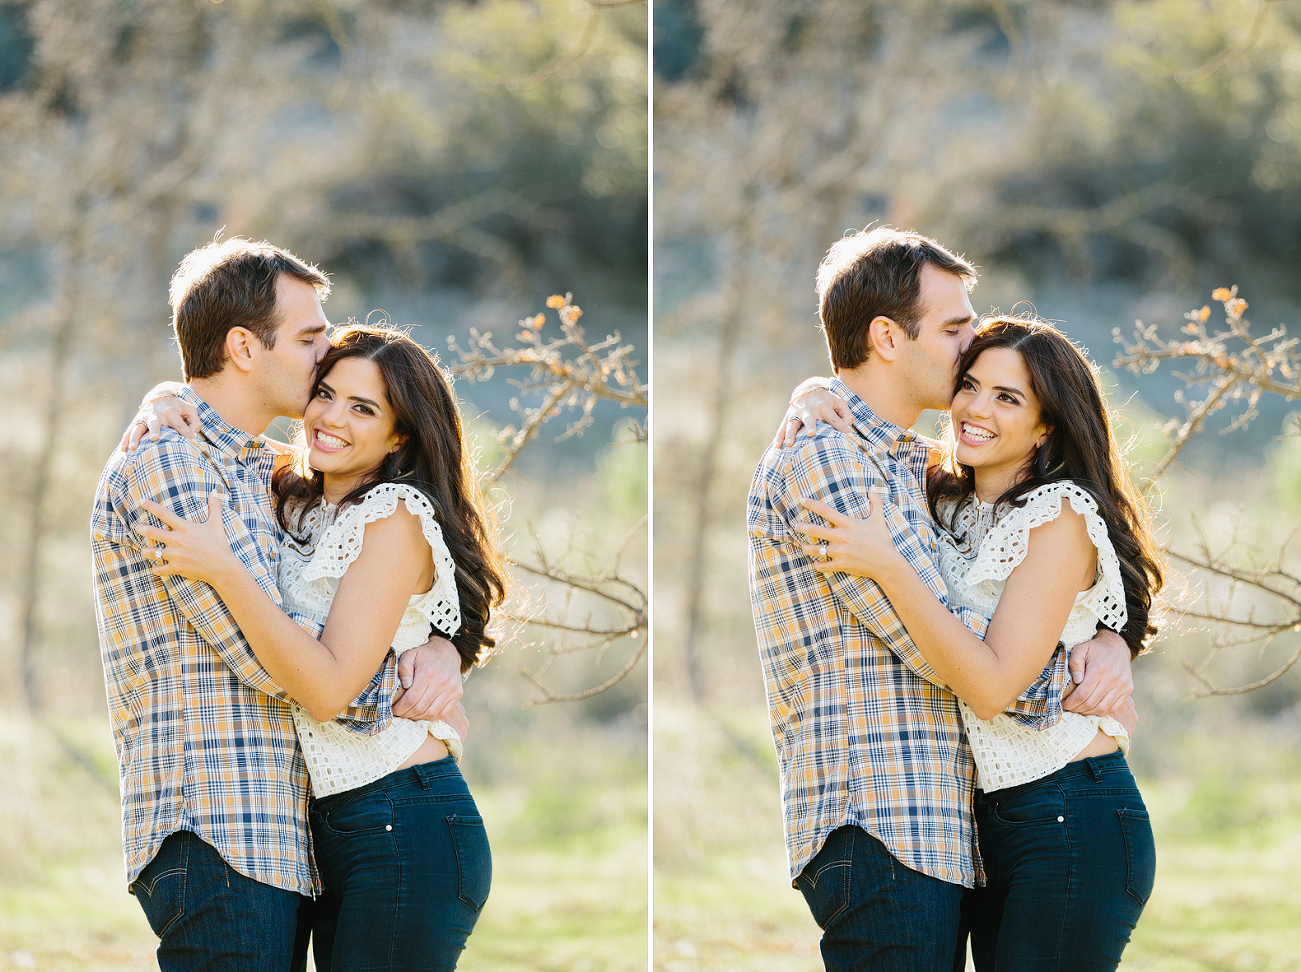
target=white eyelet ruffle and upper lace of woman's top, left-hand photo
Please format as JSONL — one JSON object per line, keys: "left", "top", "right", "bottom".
{"left": 281, "top": 483, "right": 461, "bottom": 635}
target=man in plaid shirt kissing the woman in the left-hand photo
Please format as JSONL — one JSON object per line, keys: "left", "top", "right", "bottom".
{"left": 91, "top": 238, "right": 463, "bottom": 971}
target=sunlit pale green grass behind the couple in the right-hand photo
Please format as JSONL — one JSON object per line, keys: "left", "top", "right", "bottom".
{"left": 654, "top": 700, "right": 1301, "bottom": 972}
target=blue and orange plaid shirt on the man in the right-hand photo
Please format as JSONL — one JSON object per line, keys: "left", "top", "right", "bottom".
{"left": 747, "top": 381, "right": 1067, "bottom": 887}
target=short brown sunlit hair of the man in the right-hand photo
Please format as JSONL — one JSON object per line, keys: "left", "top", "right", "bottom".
{"left": 817, "top": 226, "right": 976, "bottom": 371}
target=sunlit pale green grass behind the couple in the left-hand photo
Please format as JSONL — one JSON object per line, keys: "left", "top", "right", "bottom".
{"left": 0, "top": 717, "right": 648, "bottom": 972}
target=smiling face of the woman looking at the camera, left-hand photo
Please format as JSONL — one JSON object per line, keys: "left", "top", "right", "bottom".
{"left": 303, "top": 358, "right": 403, "bottom": 502}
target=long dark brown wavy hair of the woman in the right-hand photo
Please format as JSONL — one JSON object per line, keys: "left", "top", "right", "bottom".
{"left": 926, "top": 317, "right": 1164, "bottom": 655}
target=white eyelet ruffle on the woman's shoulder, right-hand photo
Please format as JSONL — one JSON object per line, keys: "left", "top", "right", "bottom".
{"left": 965, "top": 480, "right": 1129, "bottom": 631}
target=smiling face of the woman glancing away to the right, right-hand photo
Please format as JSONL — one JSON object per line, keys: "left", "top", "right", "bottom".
{"left": 950, "top": 347, "right": 1051, "bottom": 501}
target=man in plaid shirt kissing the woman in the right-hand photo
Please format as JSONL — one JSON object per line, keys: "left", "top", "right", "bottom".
{"left": 747, "top": 228, "right": 1129, "bottom": 972}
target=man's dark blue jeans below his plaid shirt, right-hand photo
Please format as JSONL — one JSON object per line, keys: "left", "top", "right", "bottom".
{"left": 795, "top": 826, "right": 967, "bottom": 972}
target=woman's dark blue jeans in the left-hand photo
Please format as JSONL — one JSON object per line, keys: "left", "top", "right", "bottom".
{"left": 311, "top": 756, "right": 492, "bottom": 972}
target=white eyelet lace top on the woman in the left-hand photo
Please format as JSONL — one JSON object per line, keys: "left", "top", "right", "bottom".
{"left": 278, "top": 483, "right": 462, "bottom": 796}
